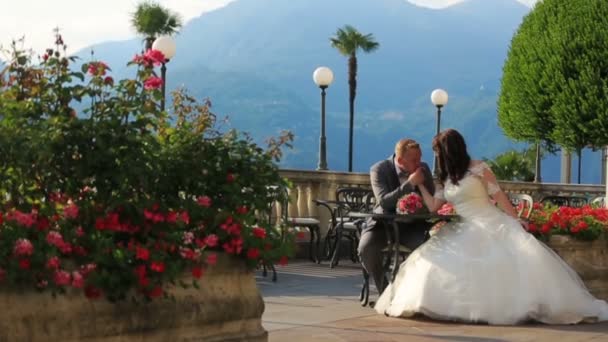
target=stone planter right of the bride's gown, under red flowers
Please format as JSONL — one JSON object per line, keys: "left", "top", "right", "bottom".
{"left": 547, "top": 235, "right": 608, "bottom": 300}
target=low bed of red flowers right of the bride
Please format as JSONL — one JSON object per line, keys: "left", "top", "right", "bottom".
{"left": 528, "top": 203, "right": 608, "bottom": 240}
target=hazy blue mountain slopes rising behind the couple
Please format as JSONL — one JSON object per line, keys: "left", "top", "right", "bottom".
{"left": 81, "top": 0, "right": 599, "bottom": 182}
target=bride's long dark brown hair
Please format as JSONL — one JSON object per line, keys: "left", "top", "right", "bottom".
{"left": 433, "top": 128, "right": 471, "bottom": 184}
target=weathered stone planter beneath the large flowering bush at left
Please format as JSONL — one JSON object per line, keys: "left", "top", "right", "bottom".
{"left": 0, "top": 254, "right": 268, "bottom": 342}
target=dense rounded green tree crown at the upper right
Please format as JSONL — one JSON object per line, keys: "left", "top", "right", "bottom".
{"left": 498, "top": 0, "right": 608, "bottom": 182}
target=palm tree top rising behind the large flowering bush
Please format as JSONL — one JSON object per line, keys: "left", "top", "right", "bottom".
{"left": 131, "top": 1, "right": 182, "bottom": 50}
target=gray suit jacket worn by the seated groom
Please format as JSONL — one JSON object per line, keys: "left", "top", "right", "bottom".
{"left": 363, "top": 155, "right": 435, "bottom": 231}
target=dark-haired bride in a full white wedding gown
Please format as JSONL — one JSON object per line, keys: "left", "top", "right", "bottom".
{"left": 375, "top": 129, "right": 608, "bottom": 324}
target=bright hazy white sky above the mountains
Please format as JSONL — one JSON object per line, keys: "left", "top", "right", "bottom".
{"left": 0, "top": 0, "right": 537, "bottom": 58}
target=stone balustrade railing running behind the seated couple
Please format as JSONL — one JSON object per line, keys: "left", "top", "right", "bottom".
{"left": 280, "top": 169, "right": 606, "bottom": 233}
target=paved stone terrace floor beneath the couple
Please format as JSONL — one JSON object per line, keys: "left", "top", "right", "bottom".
{"left": 257, "top": 260, "right": 608, "bottom": 342}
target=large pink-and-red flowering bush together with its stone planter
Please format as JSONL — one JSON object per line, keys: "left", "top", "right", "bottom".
{"left": 0, "top": 35, "right": 293, "bottom": 341}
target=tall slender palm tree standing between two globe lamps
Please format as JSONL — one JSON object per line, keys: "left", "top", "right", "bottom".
{"left": 329, "top": 25, "right": 380, "bottom": 172}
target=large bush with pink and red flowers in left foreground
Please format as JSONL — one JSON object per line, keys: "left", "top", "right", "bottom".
{"left": 0, "top": 36, "right": 293, "bottom": 301}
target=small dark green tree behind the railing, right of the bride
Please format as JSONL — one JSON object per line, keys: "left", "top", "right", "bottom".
{"left": 484, "top": 148, "right": 536, "bottom": 182}
